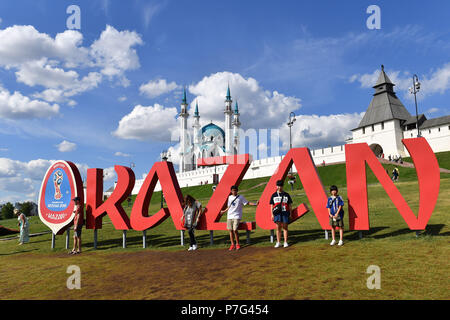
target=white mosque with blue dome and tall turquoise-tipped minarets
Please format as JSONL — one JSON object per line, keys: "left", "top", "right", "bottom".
{"left": 179, "top": 85, "right": 241, "bottom": 173}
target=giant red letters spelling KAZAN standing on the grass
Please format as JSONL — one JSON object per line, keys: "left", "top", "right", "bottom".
{"left": 37, "top": 138, "right": 440, "bottom": 230}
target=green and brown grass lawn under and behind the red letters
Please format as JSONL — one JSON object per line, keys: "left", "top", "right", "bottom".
{"left": 0, "top": 165, "right": 450, "bottom": 299}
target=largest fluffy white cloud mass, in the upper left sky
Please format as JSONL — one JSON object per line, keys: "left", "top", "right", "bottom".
{"left": 0, "top": 25, "right": 143, "bottom": 112}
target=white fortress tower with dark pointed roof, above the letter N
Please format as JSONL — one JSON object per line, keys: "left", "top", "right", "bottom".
{"left": 351, "top": 65, "right": 412, "bottom": 157}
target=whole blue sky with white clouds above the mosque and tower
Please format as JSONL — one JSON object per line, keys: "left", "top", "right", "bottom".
{"left": 0, "top": 0, "right": 450, "bottom": 203}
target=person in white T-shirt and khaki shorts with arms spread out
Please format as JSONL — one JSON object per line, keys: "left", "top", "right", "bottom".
{"left": 220, "top": 186, "right": 258, "bottom": 251}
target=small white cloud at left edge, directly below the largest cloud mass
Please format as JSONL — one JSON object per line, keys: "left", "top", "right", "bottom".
{"left": 0, "top": 86, "right": 59, "bottom": 119}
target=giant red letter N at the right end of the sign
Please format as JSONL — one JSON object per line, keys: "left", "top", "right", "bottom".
{"left": 345, "top": 138, "right": 440, "bottom": 230}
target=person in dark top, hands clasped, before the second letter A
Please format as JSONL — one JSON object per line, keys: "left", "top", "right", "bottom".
{"left": 270, "top": 180, "right": 292, "bottom": 248}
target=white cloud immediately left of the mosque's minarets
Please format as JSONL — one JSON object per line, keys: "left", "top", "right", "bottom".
{"left": 113, "top": 103, "right": 178, "bottom": 141}
